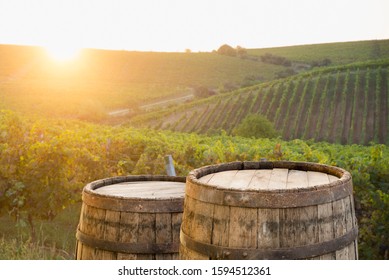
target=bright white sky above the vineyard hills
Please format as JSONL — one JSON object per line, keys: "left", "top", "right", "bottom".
{"left": 0, "top": 0, "right": 389, "bottom": 52}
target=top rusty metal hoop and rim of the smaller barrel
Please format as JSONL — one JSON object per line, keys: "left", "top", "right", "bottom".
{"left": 82, "top": 175, "right": 186, "bottom": 213}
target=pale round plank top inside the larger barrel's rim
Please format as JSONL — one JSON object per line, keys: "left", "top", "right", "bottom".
{"left": 199, "top": 168, "right": 339, "bottom": 190}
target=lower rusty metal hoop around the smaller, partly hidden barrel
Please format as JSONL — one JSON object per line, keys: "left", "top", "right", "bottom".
{"left": 76, "top": 230, "right": 180, "bottom": 254}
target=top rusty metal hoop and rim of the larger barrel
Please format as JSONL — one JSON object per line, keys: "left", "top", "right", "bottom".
{"left": 185, "top": 162, "right": 353, "bottom": 208}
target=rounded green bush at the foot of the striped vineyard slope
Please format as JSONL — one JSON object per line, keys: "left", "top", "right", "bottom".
{"left": 233, "top": 114, "right": 279, "bottom": 138}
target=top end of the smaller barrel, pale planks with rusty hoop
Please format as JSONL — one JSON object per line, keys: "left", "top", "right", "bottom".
{"left": 82, "top": 175, "right": 186, "bottom": 213}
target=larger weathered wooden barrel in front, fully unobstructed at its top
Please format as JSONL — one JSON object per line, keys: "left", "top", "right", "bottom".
{"left": 180, "top": 162, "right": 358, "bottom": 259}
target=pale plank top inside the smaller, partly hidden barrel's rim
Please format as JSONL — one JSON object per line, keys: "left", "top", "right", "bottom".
{"left": 94, "top": 181, "right": 185, "bottom": 199}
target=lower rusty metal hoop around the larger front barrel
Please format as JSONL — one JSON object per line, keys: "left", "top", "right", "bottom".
{"left": 180, "top": 227, "right": 358, "bottom": 260}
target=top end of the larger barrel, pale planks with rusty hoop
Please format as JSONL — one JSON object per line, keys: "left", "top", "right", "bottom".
{"left": 185, "top": 161, "right": 352, "bottom": 208}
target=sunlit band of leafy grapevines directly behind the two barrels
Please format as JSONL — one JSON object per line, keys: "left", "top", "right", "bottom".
{"left": 0, "top": 109, "right": 389, "bottom": 258}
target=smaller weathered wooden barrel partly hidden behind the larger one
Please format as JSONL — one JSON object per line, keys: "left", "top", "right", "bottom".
{"left": 76, "top": 175, "right": 185, "bottom": 260}
